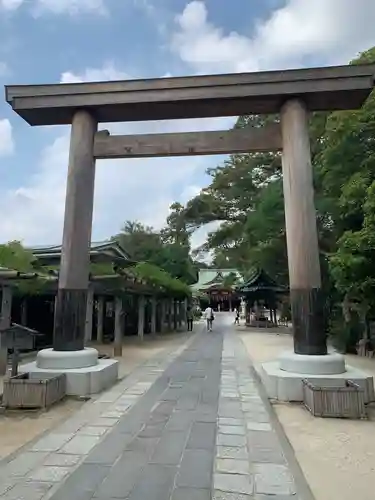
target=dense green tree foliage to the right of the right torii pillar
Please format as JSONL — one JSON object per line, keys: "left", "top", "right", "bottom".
{"left": 315, "top": 48, "right": 375, "bottom": 349}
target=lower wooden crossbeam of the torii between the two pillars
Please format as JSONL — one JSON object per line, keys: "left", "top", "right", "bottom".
{"left": 94, "top": 124, "right": 282, "bottom": 159}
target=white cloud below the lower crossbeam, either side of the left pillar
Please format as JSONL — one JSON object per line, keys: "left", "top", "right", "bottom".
{"left": 0, "top": 134, "right": 204, "bottom": 244}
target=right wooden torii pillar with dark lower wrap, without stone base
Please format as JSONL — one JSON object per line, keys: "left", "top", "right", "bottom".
{"left": 281, "top": 99, "right": 327, "bottom": 355}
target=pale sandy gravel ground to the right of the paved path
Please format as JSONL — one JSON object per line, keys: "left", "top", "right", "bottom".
{"left": 238, "top": 327, "right": 375, "bottom": 500}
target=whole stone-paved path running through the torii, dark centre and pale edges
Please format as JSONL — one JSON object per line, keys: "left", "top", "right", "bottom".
{"left": 0, "top": 316, "right": 306, "bottom": 500}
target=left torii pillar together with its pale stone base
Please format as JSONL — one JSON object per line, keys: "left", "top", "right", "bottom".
{"left": 27, "top": 110, "right": 118, "bottom": 396}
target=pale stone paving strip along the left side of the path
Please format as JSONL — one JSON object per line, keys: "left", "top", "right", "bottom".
{"left": 0, "top": 338, "right": 193, "bottom": 500}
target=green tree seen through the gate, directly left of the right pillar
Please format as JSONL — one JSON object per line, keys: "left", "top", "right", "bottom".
{"left": 185, "top": 115, "right": 287, "bottom": 278}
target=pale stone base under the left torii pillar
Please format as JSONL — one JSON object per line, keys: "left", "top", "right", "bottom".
{"left": 19, "top": 348, "right": 118, "bottom": 396}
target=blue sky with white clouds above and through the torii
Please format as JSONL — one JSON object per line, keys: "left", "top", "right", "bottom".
{"left": 0, "top": 0, "right": 375, "bottom": 244}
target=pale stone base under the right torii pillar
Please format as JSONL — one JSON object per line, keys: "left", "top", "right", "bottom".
{"left": 259, "top": 352, "right": 374, "bottom": 403}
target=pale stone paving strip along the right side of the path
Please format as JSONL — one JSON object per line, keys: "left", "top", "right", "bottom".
{"left": 212, "top": 329, "right": 297, "bottom": 500}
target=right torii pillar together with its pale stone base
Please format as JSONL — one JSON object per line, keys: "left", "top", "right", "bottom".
{"left": 262, "top": 99, "right": 352, "bottom": 401}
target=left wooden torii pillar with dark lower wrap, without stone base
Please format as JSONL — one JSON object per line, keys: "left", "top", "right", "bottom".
{"left": 53, "top": 110, "right": 97, "bottom": 351}
